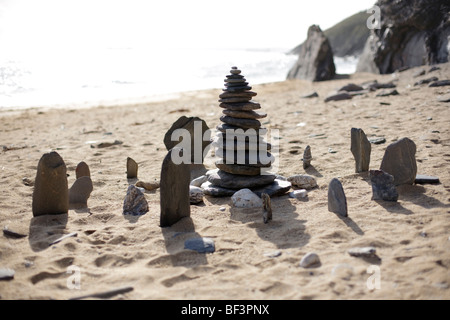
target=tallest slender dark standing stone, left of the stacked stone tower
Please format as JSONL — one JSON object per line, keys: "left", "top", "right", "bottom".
{"left": 159, "top": 147, "right": 191, "bottom": 227}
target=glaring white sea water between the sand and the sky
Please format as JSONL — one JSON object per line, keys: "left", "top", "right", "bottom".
{"left": 0, "top": 47, "right": 356, "bottom": 110}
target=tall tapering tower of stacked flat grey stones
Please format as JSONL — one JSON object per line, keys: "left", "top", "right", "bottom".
{"left": 202, "top": 67, "right": 291, "bottom": 196}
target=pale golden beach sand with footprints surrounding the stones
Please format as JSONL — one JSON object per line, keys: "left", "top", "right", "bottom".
{"left": 0, "top": 64, "right": 450, "bottom": 300}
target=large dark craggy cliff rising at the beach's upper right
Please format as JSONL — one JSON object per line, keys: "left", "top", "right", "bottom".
{"left": 356, "top": 0, "right": 450, "bottom": 74}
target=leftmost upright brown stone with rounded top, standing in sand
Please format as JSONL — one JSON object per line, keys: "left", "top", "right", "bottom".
{"left": 32, "top": 151, "right": 69, "bottom": 217}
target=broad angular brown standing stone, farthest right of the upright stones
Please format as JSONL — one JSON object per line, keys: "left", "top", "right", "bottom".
{"left": 380, "top": 138, "right": 417, "bottom": 185}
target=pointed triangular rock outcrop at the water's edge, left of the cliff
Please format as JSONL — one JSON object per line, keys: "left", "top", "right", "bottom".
{"left": 287, "top": 25, "right": 336, "bottom": 81}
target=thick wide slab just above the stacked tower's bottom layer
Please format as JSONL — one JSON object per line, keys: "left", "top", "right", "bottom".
{"left": 208, "top": 170, "right": 275, "bottom": 190}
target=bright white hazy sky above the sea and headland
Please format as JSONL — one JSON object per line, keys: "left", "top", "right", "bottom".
{"left": 0, "top": 0, "right": 375, "bottom": 50}
